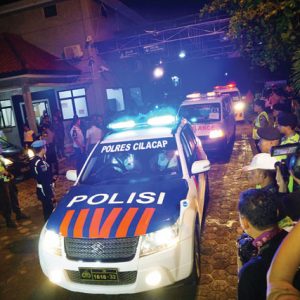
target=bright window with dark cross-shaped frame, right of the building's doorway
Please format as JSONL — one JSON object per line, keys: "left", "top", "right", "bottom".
{"left": 58, "top": 88, "right": 89, "bottom": 120}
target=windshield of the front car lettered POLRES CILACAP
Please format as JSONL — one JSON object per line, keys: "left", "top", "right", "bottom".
{"left": 80, "top": 138, "right": 181, "bottom": 184}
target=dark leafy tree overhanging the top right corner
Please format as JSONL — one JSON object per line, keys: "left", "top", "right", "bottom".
{"left": 200, "top": 0, "right": 300, "bottom": 75}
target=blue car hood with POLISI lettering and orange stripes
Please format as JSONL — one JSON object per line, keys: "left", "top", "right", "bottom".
{"left": 46, "top": 179, "right": 188, "bottom": 238}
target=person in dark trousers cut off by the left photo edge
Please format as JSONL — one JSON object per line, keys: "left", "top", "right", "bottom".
{"left": 0, "top": 146, "right": 28, "bottom": 228}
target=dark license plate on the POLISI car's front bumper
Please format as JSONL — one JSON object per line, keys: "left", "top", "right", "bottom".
{"left": 79, "top": 268, "right": 119, "bottom": 281}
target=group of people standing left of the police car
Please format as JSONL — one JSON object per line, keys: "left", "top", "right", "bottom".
{"left": 0, "top": 110, "right": 105, "bottom": 228}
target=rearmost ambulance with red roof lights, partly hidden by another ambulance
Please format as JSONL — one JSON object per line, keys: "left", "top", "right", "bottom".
{"left": 214, "top": 82, "right": 247, "bottom": 121}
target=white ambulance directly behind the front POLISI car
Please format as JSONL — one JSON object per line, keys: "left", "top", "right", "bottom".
{"left": 178, "top": 92, "right": 236, "bottom": 155}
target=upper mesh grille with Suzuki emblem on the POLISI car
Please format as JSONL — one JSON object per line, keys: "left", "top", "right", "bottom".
{"left": 65, "top": 237, "right": 139, "bottom": 262}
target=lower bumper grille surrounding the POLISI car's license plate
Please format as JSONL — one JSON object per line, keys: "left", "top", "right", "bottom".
{"left": 66, "top": 270, "right": 137, "bottom": 285}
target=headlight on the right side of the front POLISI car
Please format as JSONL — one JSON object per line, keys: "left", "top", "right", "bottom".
{"left": 140, "top": 221, "right": 179, "bottom": 256}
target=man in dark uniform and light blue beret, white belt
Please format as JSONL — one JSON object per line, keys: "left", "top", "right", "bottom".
{"left": 30, "top": 140, "right": 54, "bottom": 221}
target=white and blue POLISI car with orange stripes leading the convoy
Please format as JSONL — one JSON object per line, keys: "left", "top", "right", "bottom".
{"left": 39, "top": 115, "right": 210, "bottom": 294}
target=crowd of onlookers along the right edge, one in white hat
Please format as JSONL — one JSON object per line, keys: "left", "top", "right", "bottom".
{"left": 237, "top": 87, "right": 300, "bottom": 300}
